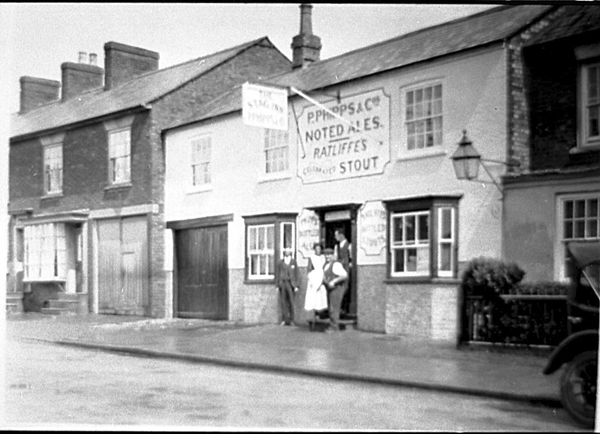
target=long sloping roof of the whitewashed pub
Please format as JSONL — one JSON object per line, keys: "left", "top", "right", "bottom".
{"left": 169, "top": 5, "right": 554, "bottom": 128}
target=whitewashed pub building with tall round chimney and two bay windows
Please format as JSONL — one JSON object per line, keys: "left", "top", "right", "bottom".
{"left": 163, "top": 5, "right": 542, "bottom": 342}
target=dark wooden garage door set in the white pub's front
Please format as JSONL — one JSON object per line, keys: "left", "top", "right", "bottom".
{"left": 175, "top": 225, "right": 228, "bottom": 319}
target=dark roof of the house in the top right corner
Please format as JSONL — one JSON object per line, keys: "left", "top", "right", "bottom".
{"left": 524, "top": 5, "right": 600, "bottom": 45}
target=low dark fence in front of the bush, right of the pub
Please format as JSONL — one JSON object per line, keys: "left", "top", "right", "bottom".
{"left": 462, "top": 295, "right": 567, "bottom": 347}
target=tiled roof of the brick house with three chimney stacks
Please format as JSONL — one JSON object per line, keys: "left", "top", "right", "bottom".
{"left": 10, "top": 37, "right": 274, "bottom": 138}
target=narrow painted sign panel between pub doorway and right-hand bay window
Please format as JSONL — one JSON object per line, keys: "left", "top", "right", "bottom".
{"left": 358, "top": 201, "right": 387, "bottom": 256}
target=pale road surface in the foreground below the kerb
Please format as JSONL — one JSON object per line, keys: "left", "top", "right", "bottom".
{"left": 6, "top": 339, "right": 580, "bottom": 431}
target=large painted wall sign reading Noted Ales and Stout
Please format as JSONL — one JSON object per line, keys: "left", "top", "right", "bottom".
{"left": 298, "top": 89, "right": 390, "bottom": 184}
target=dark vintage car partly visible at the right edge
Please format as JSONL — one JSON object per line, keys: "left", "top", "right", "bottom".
{"left": 543, "top": 242, "right": 600, "bottom": 427}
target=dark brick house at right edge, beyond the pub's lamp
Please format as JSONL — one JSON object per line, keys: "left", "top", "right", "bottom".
{"left": 502, "top": 5, "right": 600, "bottom": 281}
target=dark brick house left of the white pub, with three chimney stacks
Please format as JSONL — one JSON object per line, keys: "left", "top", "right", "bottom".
{"left": 7, "top": 37, "right": 291, "bottom": 317}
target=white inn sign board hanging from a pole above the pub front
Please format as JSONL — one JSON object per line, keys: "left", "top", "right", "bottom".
{"left": 242, "top": 83, "right": 288, "bottom": 131}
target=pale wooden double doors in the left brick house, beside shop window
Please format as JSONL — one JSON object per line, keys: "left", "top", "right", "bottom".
{"left": 98, "top": 216, "right": 148, "bottom": 315}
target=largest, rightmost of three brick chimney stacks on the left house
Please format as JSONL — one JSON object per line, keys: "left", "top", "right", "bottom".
{"left": 104, "top": 42, "right": 159, "bottom": 90}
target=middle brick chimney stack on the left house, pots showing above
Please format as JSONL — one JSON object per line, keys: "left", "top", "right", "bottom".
{"left": 60, "top": 51, "right": 104, "bottom": 101}
